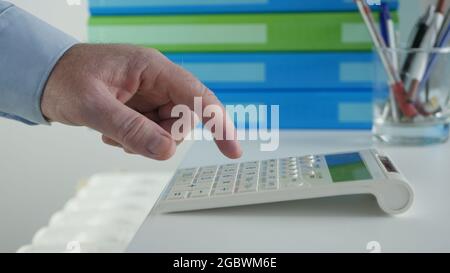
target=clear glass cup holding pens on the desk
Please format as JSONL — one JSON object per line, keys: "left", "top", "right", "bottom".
{"left": 373, "top": 47, "right": 450, "bottom": 146}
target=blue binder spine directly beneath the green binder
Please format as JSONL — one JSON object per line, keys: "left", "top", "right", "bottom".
{"left": 167, "top": 52, "right": 376, "bottom": 92}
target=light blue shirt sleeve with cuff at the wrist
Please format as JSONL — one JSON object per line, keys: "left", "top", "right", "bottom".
{"left": 0, "top": 0, "right": 77, "bottom": 124}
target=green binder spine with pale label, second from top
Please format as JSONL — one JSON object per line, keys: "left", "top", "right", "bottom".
{"left": 89, "top": 12, "right": 398, "bottom": 52}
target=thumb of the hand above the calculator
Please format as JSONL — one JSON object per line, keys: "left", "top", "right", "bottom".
{"left": 85, "top": 97, "right": 176, "bottom": 160}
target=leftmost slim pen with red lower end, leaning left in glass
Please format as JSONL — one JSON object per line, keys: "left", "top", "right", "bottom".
{"left": 355, "top": 0, "right": 418, "bottom": 117}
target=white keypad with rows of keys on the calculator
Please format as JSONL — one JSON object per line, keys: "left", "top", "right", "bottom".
{"left": 166, "top": 155, "right": 328, "bottom": 200}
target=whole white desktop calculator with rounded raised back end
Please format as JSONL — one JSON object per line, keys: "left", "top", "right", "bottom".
{"left": 156, "top": 149, "right": 414, "bottom": 214}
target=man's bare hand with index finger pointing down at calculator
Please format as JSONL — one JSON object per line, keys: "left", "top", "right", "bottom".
{"left": 41, "top": 44, "right": 242, "bottom": 160}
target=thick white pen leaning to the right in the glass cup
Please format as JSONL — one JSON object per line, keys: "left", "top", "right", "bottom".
{"left": 408, "top": 0, "right": 445, "bottom": 101}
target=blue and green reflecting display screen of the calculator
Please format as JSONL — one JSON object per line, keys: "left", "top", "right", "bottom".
{"left": 325, "top": 153, "right": 372, "bottom": 183}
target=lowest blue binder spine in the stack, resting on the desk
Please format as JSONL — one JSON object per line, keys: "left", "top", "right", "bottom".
{"left": 216, "top": 90, "right": 373, "bottom": 130}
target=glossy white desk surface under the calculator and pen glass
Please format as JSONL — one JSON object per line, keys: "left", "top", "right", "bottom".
{"left": 128, "top": 131, "right": 450, "bottom": 252}
